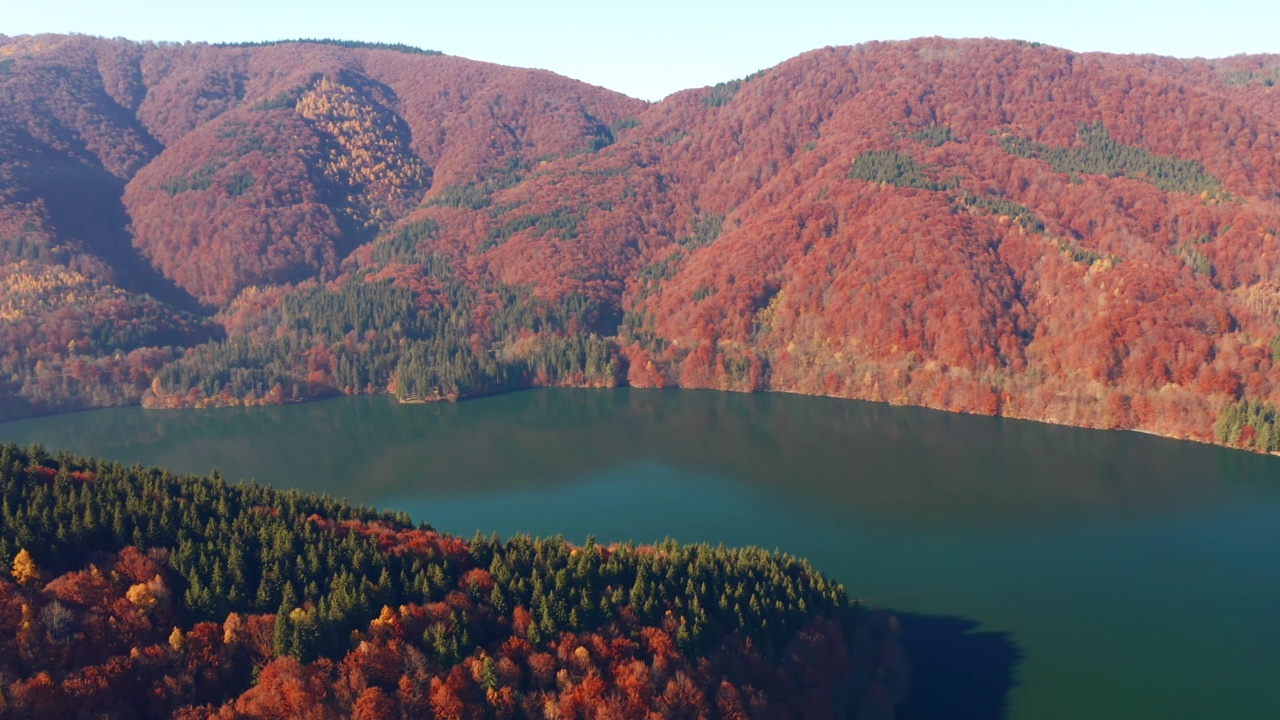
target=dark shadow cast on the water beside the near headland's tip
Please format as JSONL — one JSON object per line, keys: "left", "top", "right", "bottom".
{"left": 895, "top": 612, "right": 1023, "bottom": 720}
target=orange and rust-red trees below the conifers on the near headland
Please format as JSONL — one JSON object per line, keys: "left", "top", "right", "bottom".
{"left": 0, "top": 538, "right": 902, "bottom": 720}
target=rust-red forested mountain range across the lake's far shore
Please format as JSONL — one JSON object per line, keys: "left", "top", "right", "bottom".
{"left": 0, "top": 36, "right": 1280, "bottom": 450}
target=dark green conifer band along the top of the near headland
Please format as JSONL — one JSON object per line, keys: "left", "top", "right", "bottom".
{"left": 0, "top": 445, "right": 854, "bottom": 666}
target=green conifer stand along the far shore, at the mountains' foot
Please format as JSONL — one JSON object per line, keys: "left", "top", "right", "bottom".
{"left": 157, "top": 222, "right": 622, "bottom": 401}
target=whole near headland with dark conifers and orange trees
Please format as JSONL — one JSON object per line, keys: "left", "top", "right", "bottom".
{"left": 0, "top": 445, "right": 905, "bottom": 720}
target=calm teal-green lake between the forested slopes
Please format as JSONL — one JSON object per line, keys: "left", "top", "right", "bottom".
{"left": 0, "top": 389, "right": 1280, "bottom": 720}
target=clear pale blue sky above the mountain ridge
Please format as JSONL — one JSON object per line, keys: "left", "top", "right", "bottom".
{"left": 0, "top": 0, "right": 1280, "bottom": 100}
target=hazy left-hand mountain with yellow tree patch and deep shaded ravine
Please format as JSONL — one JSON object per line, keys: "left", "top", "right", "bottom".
{"left": 0, "top": 36, "right": 644, "bottom": 419}
